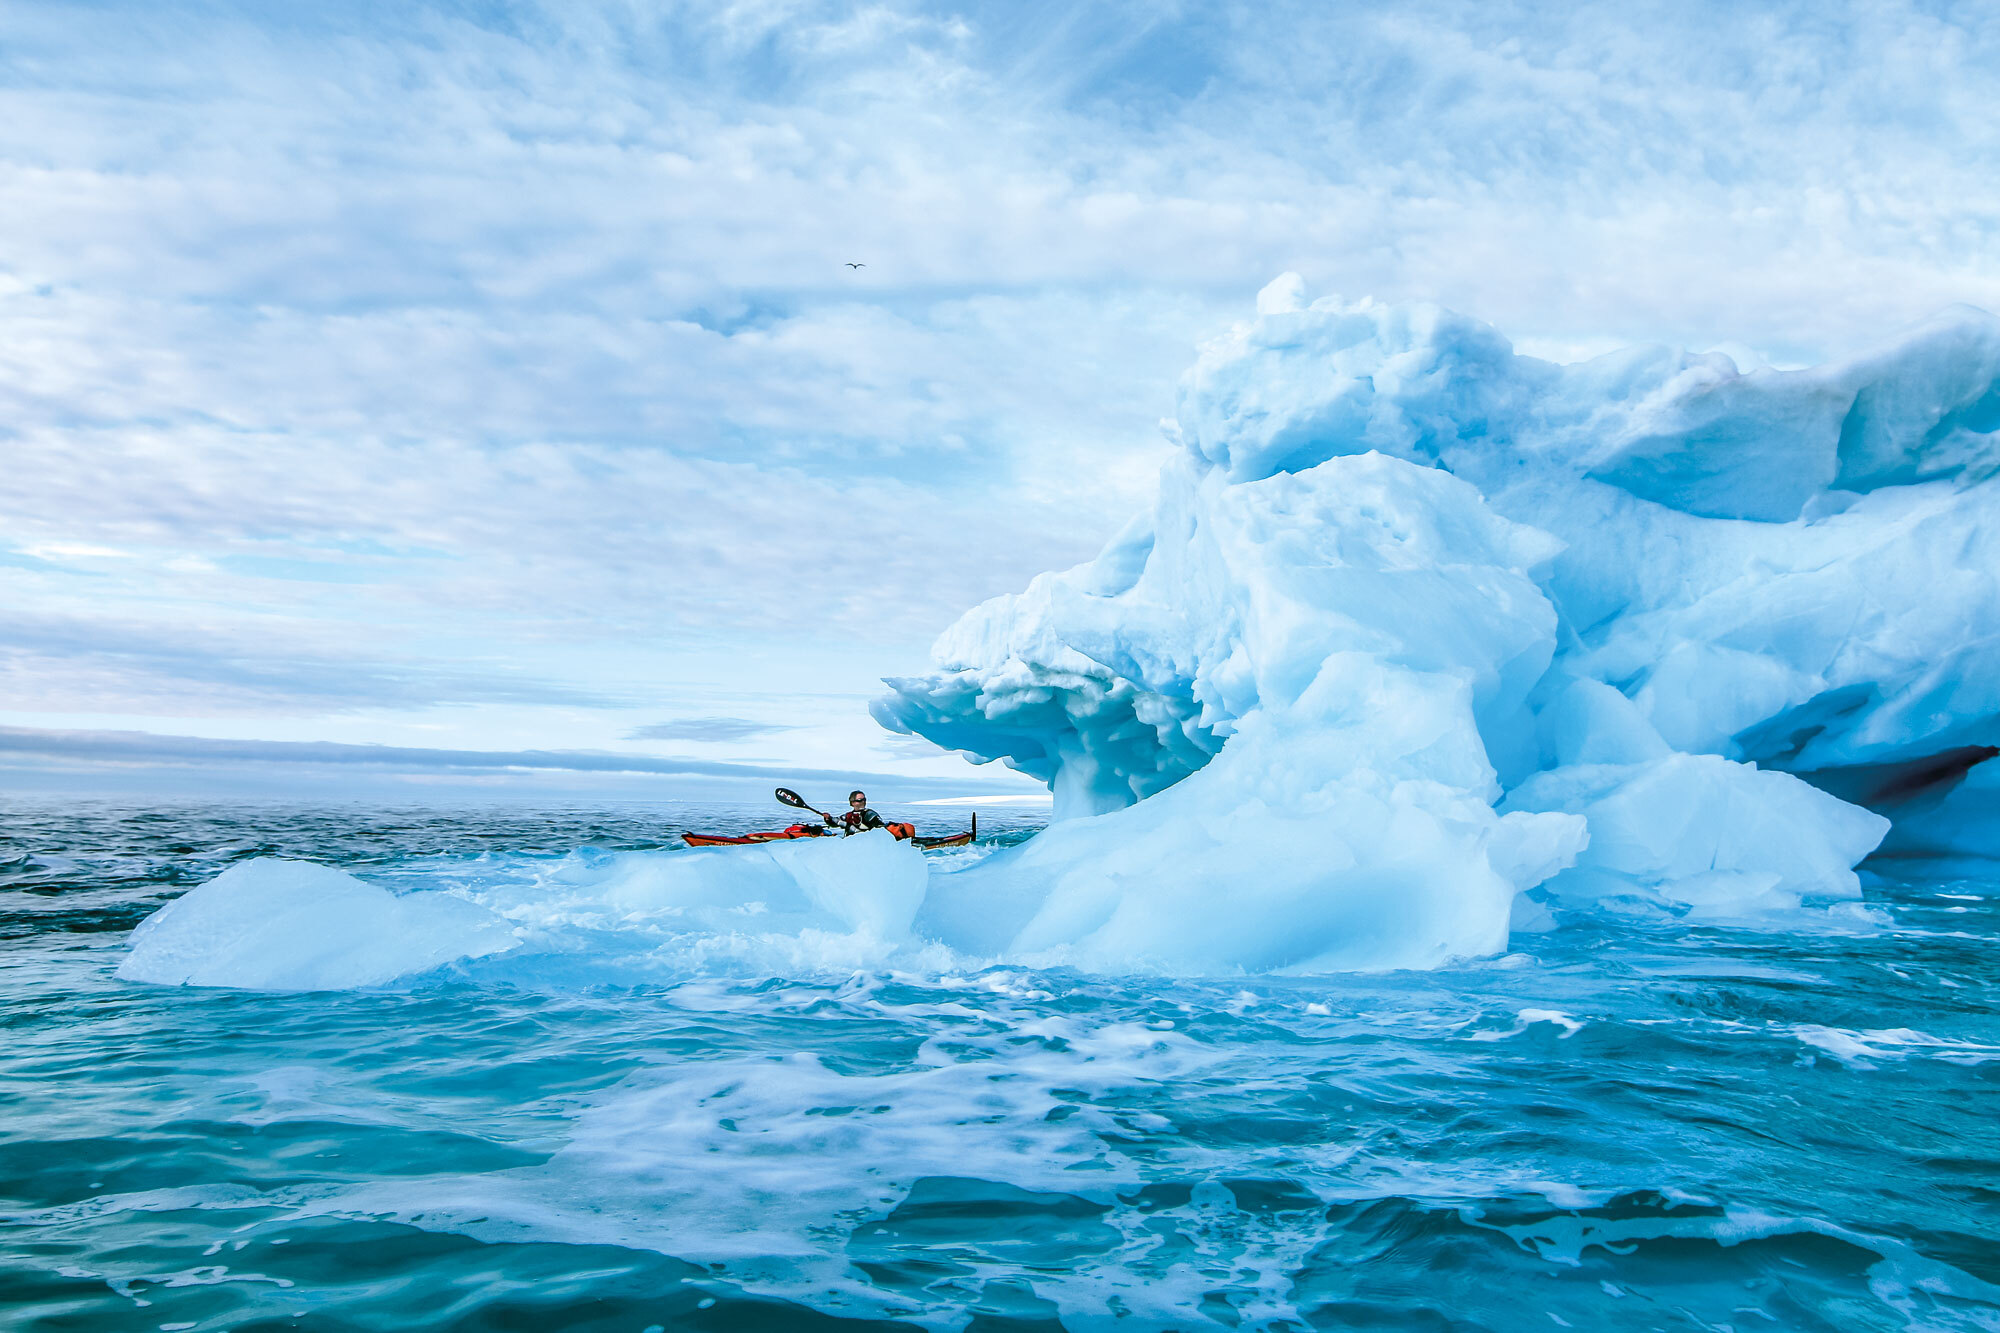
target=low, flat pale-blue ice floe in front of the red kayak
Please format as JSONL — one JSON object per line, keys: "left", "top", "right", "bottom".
{"left": 118, "top": 833, "right": 930, "bottom": 991}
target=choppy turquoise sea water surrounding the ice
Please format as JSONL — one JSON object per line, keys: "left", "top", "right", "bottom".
{"left": 0, "top": 801, "right": 2000, "bottom": 1333}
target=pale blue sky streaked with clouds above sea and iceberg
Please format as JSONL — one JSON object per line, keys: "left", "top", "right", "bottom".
{"left": 0, "top": 0, "right": 2000, "bottom": 799}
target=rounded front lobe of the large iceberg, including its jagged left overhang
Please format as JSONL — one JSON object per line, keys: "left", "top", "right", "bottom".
{"left": 916, "top": 454, "right": 1582, "bottom": 973}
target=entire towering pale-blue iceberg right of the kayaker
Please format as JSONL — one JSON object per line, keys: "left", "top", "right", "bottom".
{"left": 876, "top": 274, "right": 2000, "bottom": 940}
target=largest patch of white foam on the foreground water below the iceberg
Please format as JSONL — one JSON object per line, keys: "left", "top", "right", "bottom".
{"left": 332, "top": 1008, "right": 1248, "bottom": 1327}
